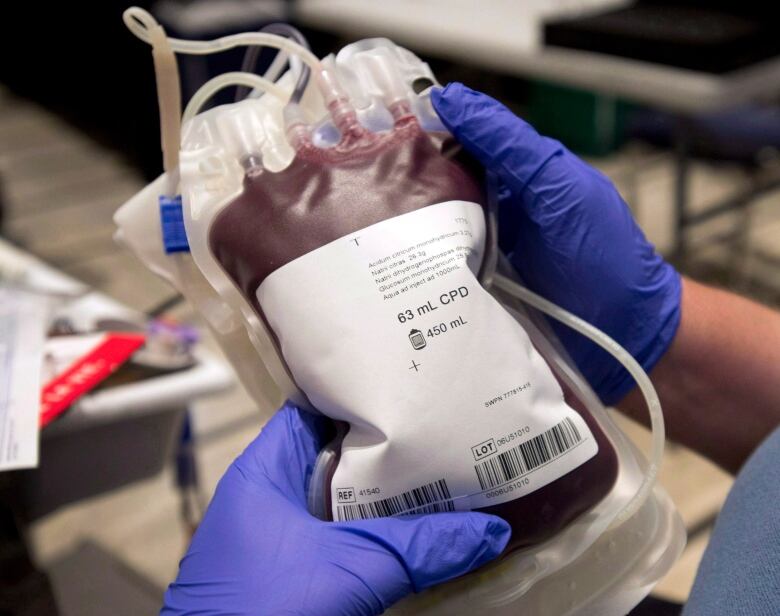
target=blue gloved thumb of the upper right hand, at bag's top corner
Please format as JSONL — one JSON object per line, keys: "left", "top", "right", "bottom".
{"left": 431, "top": 83, "right": 565, "bottom": 201}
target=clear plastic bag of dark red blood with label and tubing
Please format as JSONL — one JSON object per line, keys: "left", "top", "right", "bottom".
{"left": 118, "top": 11, "right": 682, "bottom": 614}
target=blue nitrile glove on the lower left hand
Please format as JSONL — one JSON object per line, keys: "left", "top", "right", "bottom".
{"left": 162, "top": 404, "right": 510, "bottom": 616}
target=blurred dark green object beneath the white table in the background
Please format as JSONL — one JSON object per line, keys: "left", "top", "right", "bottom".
{"left": 527, "top": 81, "right": 632, "bottom": 156}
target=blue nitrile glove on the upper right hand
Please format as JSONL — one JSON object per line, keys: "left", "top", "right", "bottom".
{"left": 431, "top": 83, "right": 681, "bottom": 404}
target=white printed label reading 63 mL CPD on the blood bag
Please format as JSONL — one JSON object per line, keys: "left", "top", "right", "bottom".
{"left": 257, "top": 201, "right": 598, "bottom": 520}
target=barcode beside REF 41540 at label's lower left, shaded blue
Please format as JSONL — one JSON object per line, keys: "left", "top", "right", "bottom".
{"left": 336, "top": 479, "right": 455, "bottom": 521}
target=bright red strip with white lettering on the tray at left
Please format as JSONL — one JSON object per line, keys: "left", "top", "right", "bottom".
{"left": 40, "top": 334, "right": 146, "bottom": 428}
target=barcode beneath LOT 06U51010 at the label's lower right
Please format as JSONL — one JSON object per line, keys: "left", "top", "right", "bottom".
{"left": 474, "top": 417, "right": 582, "bottom": 490}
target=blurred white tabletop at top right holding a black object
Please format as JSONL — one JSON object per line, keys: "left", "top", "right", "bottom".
{"left": 295, "top": 0, "right": 780, "bottom": 114}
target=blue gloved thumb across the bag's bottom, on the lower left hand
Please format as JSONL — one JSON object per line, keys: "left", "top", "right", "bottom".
{"left": 339, "top": 512, "right": 511, "bottom": 600}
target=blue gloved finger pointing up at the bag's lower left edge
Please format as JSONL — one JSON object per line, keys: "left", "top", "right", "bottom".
{"left": 234, "top": 401, "right": 330, "bottom": 507}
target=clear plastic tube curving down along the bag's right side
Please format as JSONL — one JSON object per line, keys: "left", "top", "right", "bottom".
{"left": 493, "top": 275, "right": 665, "bottom": 527}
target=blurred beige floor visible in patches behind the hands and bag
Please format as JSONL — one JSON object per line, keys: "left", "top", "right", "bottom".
{"left": 0, "top": 90, "right": 780, "bottom": 613}
